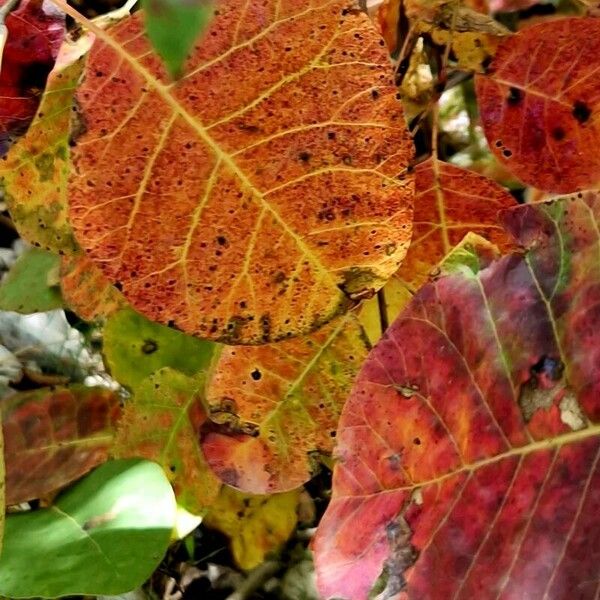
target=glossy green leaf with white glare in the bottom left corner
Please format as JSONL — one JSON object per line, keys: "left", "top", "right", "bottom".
{"left": 0, "top": 460, "right": 176, "bottom": 598}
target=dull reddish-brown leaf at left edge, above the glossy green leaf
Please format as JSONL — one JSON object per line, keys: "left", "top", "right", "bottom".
{"left": 0, "top": 385, "right": 121, "bottom": 504}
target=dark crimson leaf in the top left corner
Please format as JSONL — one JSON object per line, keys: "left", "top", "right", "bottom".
{"left": 0, "top": 0, "right": 65, "bottom": 155}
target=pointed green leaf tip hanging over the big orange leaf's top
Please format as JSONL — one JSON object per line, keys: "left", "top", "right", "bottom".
{"left": 142, "top": 0, "right": 213, "bottom": 79}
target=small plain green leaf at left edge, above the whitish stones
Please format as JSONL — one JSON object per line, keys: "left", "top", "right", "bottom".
{"left": 0, "top": 248, "right": 63, "bottom": 314}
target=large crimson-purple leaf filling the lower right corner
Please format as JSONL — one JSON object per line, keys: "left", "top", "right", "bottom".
{"left": 315, "top": 192, "right": 600, "bottom": 600}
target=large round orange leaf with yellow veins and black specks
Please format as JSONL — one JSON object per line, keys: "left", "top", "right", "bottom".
{"left": 63, "top": 0, "right": 412, "bottom": 343}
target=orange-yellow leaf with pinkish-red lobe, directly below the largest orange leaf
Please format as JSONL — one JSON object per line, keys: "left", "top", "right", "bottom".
{"left": 202, "top": 315, "right": 369, "bottom": 494}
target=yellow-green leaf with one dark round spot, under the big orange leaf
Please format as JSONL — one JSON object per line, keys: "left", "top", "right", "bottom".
{"left": 104, "top": 308, "right": 215, "bottom": 390}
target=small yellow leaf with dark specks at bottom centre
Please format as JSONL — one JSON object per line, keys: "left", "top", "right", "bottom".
{"left": 204, "top": 486, "right": 300, "bottom": 570}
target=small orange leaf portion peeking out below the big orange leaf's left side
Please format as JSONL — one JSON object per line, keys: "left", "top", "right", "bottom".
{"left": 60, "top": 252, "right": 127, "bottom": 321}
